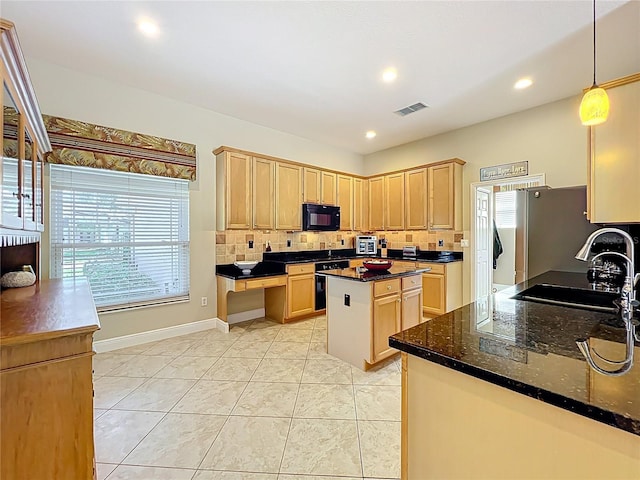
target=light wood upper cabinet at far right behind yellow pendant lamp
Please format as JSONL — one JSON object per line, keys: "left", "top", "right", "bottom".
{"left": 587, "top": 73, "right": 640, "bottom": 223}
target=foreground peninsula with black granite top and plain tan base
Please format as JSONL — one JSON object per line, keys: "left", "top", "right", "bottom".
{"left": 390, "top": 272, "right": 640, "bottom": 480}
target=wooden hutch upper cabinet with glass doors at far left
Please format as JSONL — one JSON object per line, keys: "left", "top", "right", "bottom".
{"left": 0, "top": 19, "right": 51, "bottom": 231}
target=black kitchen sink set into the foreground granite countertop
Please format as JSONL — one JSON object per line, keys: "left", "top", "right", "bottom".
{"left": 511, "top": 283, "right": 620, "bottom": 312}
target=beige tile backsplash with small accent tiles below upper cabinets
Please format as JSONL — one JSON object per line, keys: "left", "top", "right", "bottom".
{"left": 216, "top": 230, "right": 463, "bottom": 264}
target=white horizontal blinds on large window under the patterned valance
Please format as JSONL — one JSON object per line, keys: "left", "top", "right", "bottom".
{"left": 50, "top": 165, "right": 189, "bottom": 311}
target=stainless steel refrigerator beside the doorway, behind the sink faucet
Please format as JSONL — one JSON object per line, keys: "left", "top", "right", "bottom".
{"left": 516, "top": 186, "right": 600, "bottom": 283}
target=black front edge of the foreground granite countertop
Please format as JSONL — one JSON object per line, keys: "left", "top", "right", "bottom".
{"left": 389, "top": 337, "right": 640, "bottom": 436}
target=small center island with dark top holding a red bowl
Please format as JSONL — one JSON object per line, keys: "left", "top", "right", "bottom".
{"left": 317, "top": 265, "right": 429, "bottom": 370}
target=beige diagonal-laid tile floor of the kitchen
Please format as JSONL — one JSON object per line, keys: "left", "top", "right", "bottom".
{"left": 94, "top": 316, "right": 400, "bottom": 480}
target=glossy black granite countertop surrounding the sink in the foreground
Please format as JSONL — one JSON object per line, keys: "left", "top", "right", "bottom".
{"left": 389, "top": 272, "right": 640, "bottom": 435}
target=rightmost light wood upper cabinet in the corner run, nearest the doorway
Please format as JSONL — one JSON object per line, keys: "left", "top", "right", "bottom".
{"left": 427, "top": 159, "right": 464, "bottom": 230}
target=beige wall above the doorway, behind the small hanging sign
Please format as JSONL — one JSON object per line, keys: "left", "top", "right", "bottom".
{"left": 364, "top": 96, "right": 587, "bottom": 303}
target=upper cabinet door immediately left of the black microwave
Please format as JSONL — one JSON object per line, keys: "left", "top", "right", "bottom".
{"left": 276, "top": 162, "right": 302, "bottom": 230}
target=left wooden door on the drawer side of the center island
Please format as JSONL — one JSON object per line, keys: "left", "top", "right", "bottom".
{"left": 371, "top": 293, "right": 401, "bottom": 363}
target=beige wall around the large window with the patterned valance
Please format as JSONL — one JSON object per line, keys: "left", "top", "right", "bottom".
{"left": 27, "top": 58, "right": 362, "bottom": 340}
